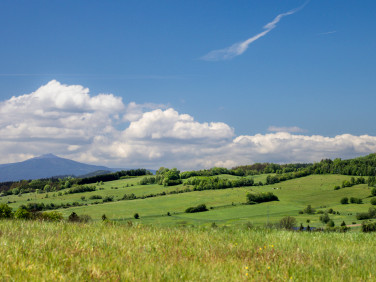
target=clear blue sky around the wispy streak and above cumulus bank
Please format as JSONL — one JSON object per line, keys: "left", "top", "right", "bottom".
{"left": 0, "top": 0, "right": 376, "bottom": 167}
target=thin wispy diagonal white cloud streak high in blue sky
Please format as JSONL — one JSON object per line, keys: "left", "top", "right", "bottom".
{"left": 201, "top": 2, "right": 308, "bottom": 61}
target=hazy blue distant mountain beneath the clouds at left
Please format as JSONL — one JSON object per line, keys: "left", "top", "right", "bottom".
{"left": 0, "top": 154, "right": 115, "bottom": 182}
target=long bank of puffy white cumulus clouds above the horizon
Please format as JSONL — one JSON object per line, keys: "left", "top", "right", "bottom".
{"left": 0, "top": 81, "right": 376, "bottom": 170}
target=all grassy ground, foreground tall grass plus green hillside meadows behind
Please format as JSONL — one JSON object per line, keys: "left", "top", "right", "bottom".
{"left": 0, "top": 174, "right": 376, "bottom": 281}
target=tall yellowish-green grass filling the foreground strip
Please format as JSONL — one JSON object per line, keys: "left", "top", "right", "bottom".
{"left": 0, "top": 220, "right": 376, "bottom": 281}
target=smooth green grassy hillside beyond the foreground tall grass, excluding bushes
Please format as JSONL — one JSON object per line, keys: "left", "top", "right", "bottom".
{"left": 0, "top": 175, "right": 370, "bottom": 227}
